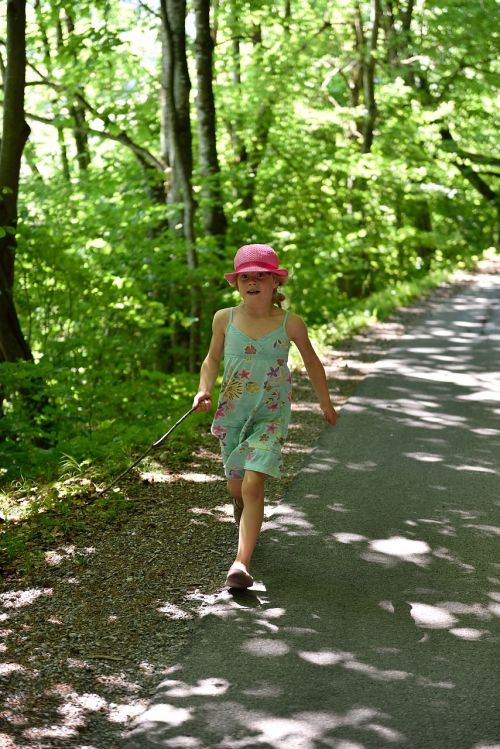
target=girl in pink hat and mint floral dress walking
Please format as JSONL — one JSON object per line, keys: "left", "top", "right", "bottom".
{"left": 193, "top": 244, "right": 337, "bottom": 588}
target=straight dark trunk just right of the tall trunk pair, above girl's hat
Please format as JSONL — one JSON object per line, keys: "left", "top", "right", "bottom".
{"left": 193, "top": 0, "right": 226, "bottom": 238}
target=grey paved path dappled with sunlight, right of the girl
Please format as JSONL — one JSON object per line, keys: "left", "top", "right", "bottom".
{"left": 126, "top": 275, "right": 500, "bottom": 749}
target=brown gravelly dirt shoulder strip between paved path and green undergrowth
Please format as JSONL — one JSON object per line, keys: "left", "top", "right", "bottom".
{"left": 0, "top": 262, "right": 500, "bottom": 749}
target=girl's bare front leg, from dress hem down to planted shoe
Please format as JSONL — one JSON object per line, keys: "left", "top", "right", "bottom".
{"left": 235, "top": 470, "right": 266, "bottom": 571}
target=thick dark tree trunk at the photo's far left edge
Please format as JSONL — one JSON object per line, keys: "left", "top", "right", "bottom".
{"left": 0, "top": 0, "right": 33, "bottom": 362}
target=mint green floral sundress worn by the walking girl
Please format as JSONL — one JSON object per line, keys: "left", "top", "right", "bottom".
{"left": 211, "top": 309, "right": 292, "bottom": 479}
